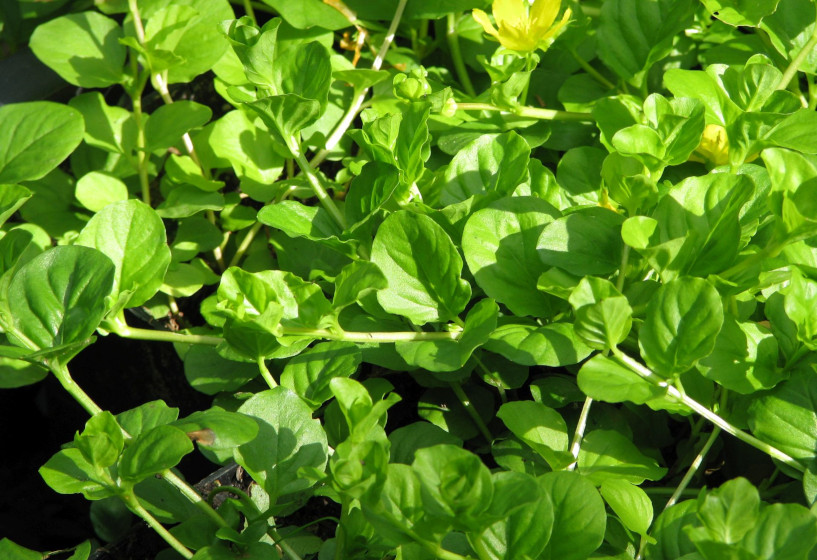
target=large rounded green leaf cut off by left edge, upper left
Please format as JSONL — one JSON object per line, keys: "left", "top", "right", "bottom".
{"left": 0, "top": 101, "right": 84, "bottom": 183}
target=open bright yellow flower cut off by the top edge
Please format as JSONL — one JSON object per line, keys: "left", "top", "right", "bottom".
{"left": 473, "top": 0, "right": 570, "bottom": 52}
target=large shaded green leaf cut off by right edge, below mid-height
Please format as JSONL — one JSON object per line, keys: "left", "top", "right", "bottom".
{"left": 748, "top": 369, "right": 817, "bottom": 465}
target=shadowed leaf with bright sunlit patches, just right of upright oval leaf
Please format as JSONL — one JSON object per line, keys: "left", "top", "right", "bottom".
{"left": 698, "top": 315, "right": 787, "bottom": 395}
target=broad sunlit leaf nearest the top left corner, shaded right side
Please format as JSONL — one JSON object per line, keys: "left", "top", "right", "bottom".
{"left": 31, "top": 12, "right": 127, "bottom": 88}
